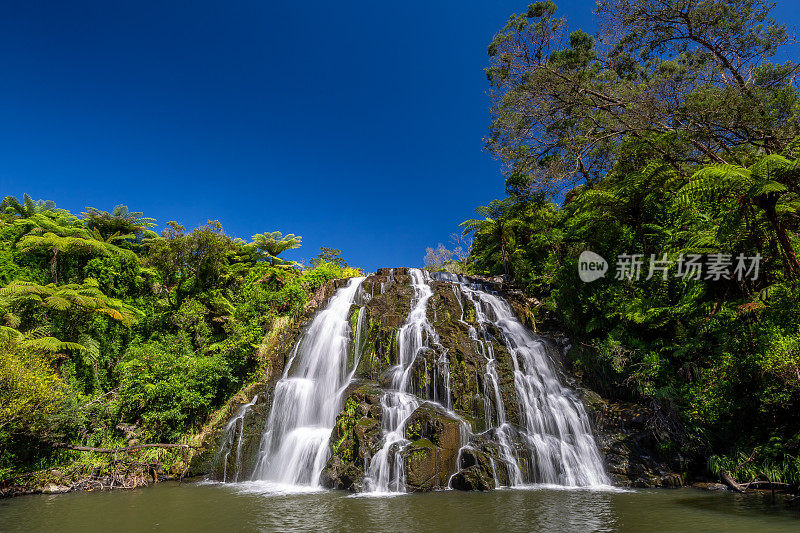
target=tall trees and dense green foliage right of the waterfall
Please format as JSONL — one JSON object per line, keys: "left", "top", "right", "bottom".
{"left": 462, "top": 0, "right": 800, "bottom": 484}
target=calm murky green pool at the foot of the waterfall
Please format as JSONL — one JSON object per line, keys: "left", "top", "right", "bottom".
{"left": 0, "top": 483, "right": 800, "bottom": 533}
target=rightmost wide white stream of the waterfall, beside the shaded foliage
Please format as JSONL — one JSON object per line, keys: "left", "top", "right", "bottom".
{"left": 447, "top": 277, "right": 610, "bottom": 486}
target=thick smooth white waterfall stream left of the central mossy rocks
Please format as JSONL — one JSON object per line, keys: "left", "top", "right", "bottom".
{"left": 253, "top": 277, "right": 364, "bottom": 488}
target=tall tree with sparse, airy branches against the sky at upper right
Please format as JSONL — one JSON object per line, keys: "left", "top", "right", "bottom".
{"left": 487, "top": 0, "right": 799, "bottom": 197}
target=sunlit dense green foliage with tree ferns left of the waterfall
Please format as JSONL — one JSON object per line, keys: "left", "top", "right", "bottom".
{"left": 0, "top": 196, "right": 358, "bottom": 481}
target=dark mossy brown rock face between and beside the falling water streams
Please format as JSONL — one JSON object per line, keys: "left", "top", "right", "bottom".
{"left": 203, "top": 268, "right": 683, "bottom": 492}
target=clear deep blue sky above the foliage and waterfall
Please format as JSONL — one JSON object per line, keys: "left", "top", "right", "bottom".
{"left": 0, "top": 0, "right": 790, "bottom": 271}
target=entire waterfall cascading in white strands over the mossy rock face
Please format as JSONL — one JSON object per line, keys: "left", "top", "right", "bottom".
{"left": 219, "top": 269, "right": 609, "bottom": 494}
